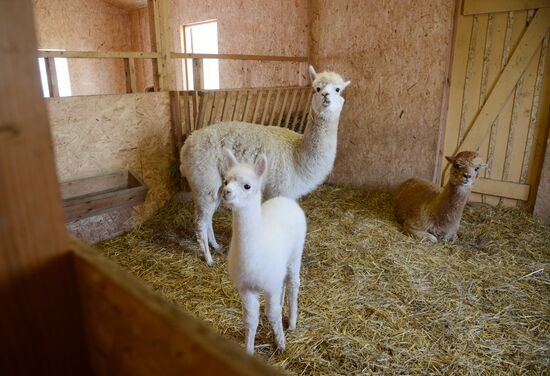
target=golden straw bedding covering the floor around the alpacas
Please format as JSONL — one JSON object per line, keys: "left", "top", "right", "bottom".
{"left": 98, "top": 186, "right": 550, "bottom": 375}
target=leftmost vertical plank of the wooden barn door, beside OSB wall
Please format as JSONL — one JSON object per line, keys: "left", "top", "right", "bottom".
{"left": 441, "top": 16, "right": 474, "bottom": 179}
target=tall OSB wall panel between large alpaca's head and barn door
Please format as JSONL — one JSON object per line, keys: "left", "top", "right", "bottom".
{"left": 310, "top": 0, "right": 454, "bottom": 189}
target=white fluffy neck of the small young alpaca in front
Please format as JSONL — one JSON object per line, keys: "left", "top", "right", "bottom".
{"left": 231, "top": 195, "right": 263, "bottom": 257}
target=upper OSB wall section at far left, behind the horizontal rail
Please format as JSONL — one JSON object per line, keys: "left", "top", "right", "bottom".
{"left": 33, "top": 0, "right": 132, "bottom": 95}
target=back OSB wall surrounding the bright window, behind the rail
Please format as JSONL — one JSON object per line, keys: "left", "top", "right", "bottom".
{"left": 131, "top": 0, "right": 309, "bottom": 90}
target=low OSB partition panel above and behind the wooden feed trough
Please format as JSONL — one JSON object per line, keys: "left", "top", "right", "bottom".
{"left": 47, "top": 92, "right": 176, "bottom": 225}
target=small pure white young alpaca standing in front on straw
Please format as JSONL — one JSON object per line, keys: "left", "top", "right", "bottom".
{"left": 222, "top": 149, "right": 306, "bottom": 353}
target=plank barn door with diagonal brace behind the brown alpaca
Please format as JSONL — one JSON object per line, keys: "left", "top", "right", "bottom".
{"left": 442, "top": 0, "right": 550, "bottom": 206}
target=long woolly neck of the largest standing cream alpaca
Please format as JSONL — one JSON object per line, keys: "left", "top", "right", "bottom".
{"left": 297, "top": 111, "right": 340, "bottom": 181}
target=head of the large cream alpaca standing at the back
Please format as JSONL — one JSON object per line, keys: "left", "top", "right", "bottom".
{"left": 309, "top": 65, "right": 351, "bottom": 114}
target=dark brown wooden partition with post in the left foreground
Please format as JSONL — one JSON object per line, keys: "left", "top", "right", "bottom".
{"left": 0, "top": 0, "right": 277, "bottom": 375}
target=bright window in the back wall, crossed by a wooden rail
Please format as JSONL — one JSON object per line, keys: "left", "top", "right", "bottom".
{"left": 181, "top": 21, "right": 220, "bottom": 90}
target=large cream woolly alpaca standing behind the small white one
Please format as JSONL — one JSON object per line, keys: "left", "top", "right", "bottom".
{"left": 180, "top": 66, "right": 350, "bottom": 265}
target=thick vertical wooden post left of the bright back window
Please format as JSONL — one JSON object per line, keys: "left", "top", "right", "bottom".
{"left": 147, "top": 0, "right": 176, "bottom": 91}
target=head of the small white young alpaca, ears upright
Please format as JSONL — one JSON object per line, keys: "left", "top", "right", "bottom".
{"left": 222, "top": 149, "right": 267, "bottom": 209}
